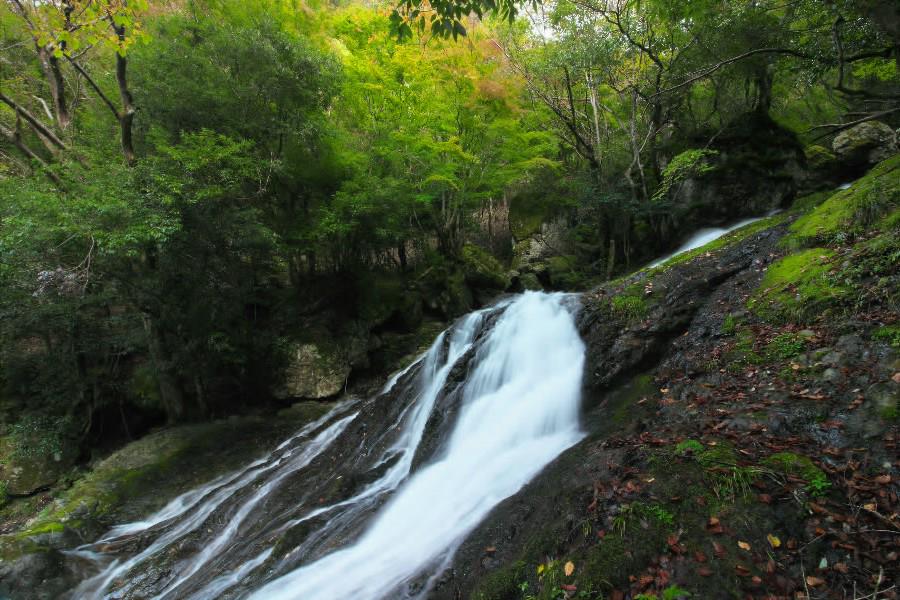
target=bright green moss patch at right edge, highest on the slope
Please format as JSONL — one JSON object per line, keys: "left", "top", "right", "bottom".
{"left": 782, "top": 154, "right": 900, "bottom": 248}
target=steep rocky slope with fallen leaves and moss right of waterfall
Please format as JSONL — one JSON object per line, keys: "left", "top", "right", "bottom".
{"left": 444, "top": 156, "right": 900, "bottom": 600}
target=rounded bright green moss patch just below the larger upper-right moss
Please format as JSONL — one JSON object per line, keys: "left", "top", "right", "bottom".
{"left": 747, "top": 248, "right": 849, "bottom": 322}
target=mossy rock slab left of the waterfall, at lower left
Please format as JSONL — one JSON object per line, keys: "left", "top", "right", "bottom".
{"left": 0, "top": 412, "right": 330, "bottom": 600}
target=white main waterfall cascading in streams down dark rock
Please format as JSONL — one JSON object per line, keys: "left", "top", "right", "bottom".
{"left": 71, "top": 292, "right": 584, "bottom": 600}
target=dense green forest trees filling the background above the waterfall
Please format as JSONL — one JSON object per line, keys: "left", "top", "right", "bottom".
{"left": 0, "top": 0, "right": 900, "bottom": 460}
